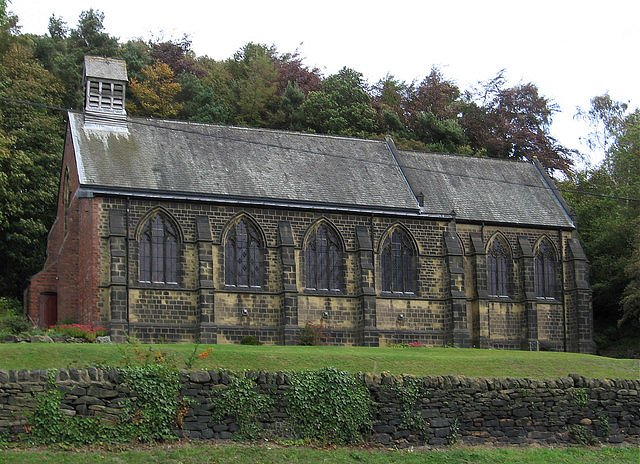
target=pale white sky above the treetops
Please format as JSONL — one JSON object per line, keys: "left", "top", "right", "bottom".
{"left": 8, "top": 0, "right": 640, "bottom": 167}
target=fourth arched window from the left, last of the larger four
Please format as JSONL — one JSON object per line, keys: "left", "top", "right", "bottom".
{"left": 380, "top": 228, "right": 416, "bottom": 293}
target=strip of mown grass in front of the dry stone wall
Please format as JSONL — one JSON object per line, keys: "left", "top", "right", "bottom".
{"left": 0, "top": 443, "right": 640, "bottom": 464}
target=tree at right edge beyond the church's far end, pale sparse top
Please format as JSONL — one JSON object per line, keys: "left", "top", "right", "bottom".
{"left": 565, "top": 98, "right": 640, "bottom": 326}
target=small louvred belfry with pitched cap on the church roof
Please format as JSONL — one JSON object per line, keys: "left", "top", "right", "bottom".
{"left": 84, "top": 56, "right": 127, "bottom": 127}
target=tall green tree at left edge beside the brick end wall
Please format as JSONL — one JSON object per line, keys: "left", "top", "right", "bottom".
{"left": 0, "top": 41, "right": 64, "bottom": 297}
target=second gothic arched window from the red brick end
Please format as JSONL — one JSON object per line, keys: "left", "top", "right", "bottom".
{"left": 224, "top": 219, "right": 264, "bottom": 287}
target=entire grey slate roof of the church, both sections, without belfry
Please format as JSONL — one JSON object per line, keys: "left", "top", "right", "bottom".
{"left": 69, "top": 112, "right": 575, "bottom": 228}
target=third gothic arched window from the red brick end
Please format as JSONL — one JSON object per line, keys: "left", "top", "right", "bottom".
{"left": 304, "top": 224, "right": 343, "bottom": 291}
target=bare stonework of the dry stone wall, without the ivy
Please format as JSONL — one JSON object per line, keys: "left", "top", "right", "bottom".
{"left": 0, "top": 368, "right": 640, "bottom": 447}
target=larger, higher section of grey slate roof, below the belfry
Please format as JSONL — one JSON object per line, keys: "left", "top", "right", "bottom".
{"left": 69, "top": 113, "right": 419, "bottom": 214}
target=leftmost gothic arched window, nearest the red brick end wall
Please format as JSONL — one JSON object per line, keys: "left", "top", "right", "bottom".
{"left": 139, "top": 213, "right": 178, "bottom": 284}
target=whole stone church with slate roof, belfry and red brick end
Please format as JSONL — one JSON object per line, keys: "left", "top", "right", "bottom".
{"left": 25, "top": 57, "right": 593, "bottom": 352}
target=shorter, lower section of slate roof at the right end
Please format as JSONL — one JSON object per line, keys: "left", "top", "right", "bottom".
{"left": 397, "top": 151, "right": 575, "bottom": 228}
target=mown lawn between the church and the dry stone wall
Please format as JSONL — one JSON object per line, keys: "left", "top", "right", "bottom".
{"left": 0, "top": 343, "right": 640, "bottom": 379}
